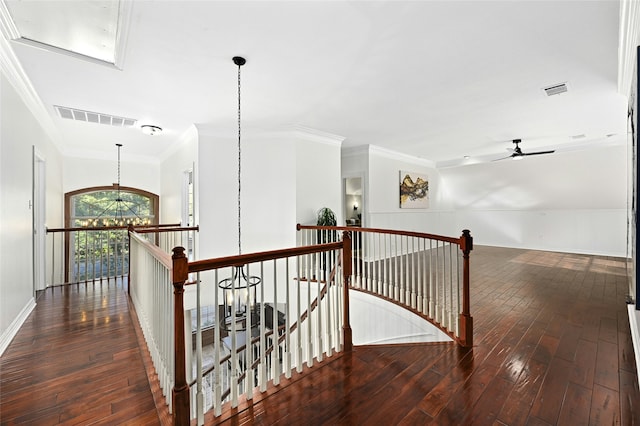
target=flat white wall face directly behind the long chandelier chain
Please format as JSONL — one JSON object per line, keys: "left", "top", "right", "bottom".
{"left": 196, "top": 126, "right": 296, "bottom": 258}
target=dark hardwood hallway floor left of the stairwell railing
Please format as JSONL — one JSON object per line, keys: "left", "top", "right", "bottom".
{"left": 0, "top": 280, "right": 160, "bottom": 425}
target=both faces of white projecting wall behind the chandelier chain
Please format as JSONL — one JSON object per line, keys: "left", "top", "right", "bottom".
{"left": 185, "top": 125, "right": 340, "bottom": 308}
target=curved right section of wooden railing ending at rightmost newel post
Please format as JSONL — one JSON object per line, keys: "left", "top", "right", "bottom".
{"left": 298, "top": 225, "right": 473, "bottom": 347}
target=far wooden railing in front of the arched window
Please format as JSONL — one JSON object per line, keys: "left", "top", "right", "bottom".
{"left": 44, "top": 224, "right": 198, "bottom": 287}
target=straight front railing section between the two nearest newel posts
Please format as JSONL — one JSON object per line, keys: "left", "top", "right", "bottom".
{"left": 172, "top": 233, "right": 352, "bottom": 425}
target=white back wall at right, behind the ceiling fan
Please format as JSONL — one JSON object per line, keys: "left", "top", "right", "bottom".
{"left": 441, "top": 145, "right": 627, "bottom": 256}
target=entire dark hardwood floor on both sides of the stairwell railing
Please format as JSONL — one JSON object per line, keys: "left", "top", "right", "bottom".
{"left": 0, "top": 247, "right": 640, "bottom": 425}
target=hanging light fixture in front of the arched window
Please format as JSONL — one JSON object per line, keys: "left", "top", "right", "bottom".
{"left": 81, "top": 143, "right": 151, "bottom": 227}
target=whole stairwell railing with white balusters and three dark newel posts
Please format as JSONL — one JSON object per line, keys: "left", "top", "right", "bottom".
{"left": 130, "top": 225, "right": 473, "bottom": 425}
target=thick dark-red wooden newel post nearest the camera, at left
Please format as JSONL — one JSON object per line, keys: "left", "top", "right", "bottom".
{"left": 171, "top": 247, "right": 191, "bottom": 426}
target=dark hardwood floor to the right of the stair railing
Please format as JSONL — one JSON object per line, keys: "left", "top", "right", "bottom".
{"left": 208, "top": 247, "right": 640, "bottom": 426}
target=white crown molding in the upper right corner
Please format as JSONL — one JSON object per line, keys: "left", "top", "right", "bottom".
{"left": 618, "top": 0, "right": 640, "bottom": 96}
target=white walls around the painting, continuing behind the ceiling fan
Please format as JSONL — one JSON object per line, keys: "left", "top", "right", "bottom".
{"left": 342, "top": 145, "right": 628, "bottom": 256}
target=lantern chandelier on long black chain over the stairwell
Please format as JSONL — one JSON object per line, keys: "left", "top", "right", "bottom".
{"left": 218, "top": 56, "right": 262, "bottom": 330}
